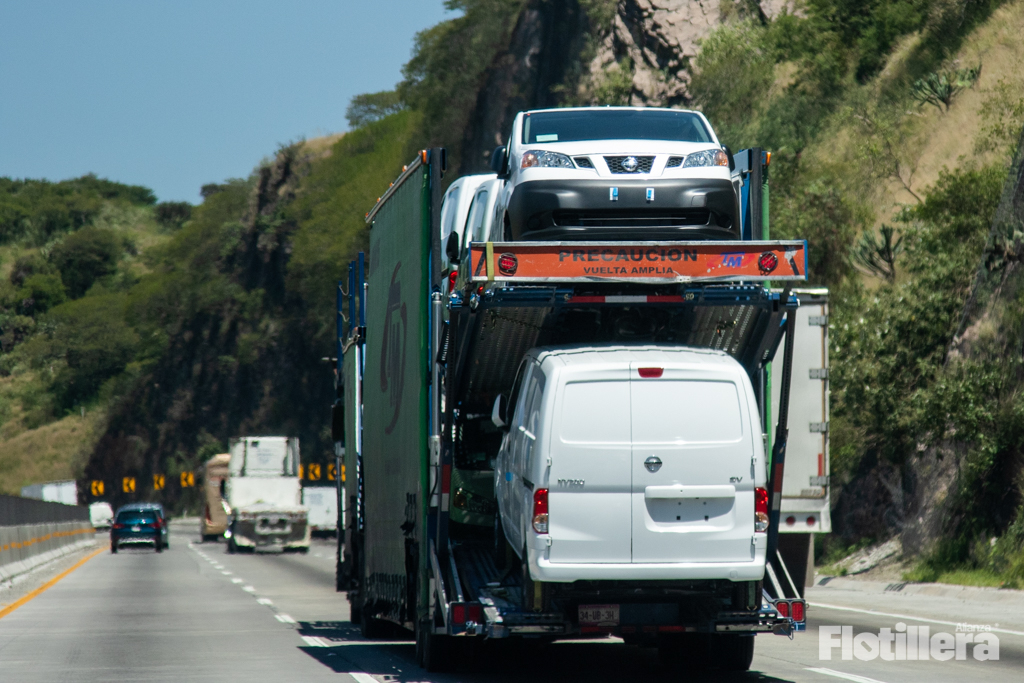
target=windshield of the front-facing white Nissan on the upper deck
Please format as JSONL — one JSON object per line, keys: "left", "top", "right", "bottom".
{"left": 522, "top": 110, "right": 713, "bottom": 144}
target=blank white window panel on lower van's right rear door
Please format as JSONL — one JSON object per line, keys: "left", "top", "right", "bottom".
{"left": 630, "top": 380, "right": 743, "bottom": 443}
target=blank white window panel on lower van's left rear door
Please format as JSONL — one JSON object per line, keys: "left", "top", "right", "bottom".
{"left": 559, "top": 381, "right": 630, "bottom": 443}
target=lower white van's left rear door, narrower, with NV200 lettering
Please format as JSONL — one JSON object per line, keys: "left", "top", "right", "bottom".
{"left": 544, "top": 370, "right": 632, "bottom": 563}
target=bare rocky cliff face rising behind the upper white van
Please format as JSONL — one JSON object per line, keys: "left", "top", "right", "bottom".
{"left": 460, "top": 0, "right": 796, "bottom": 173}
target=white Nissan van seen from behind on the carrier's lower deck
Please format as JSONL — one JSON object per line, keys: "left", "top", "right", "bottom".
{"left": 493, "top": 346, "right": 768, "bottom": 582}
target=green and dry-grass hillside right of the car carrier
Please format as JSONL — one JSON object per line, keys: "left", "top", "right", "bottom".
{"left": 693, "top": 2, "right": 1024, "bottom": 586}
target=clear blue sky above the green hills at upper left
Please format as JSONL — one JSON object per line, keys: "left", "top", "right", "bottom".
{"left": 0, "top": 0, "right": 452, "bottom": 203}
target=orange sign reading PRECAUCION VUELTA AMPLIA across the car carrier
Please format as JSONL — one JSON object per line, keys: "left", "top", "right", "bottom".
{"left": 470, "top": 240, "right": 807, "bottom": 283}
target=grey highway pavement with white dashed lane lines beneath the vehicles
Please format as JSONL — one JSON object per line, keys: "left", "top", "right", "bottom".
{"left": 0, "top": 524, "right": 1024, "bottom": 683}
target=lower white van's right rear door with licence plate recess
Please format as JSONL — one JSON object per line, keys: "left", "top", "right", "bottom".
{"left": 626, "top": 361, "right": 754, "bottom": 563}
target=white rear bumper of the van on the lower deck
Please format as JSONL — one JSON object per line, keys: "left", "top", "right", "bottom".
{"left": 527, "top": 546, "right": 765, "bottom": 583}
